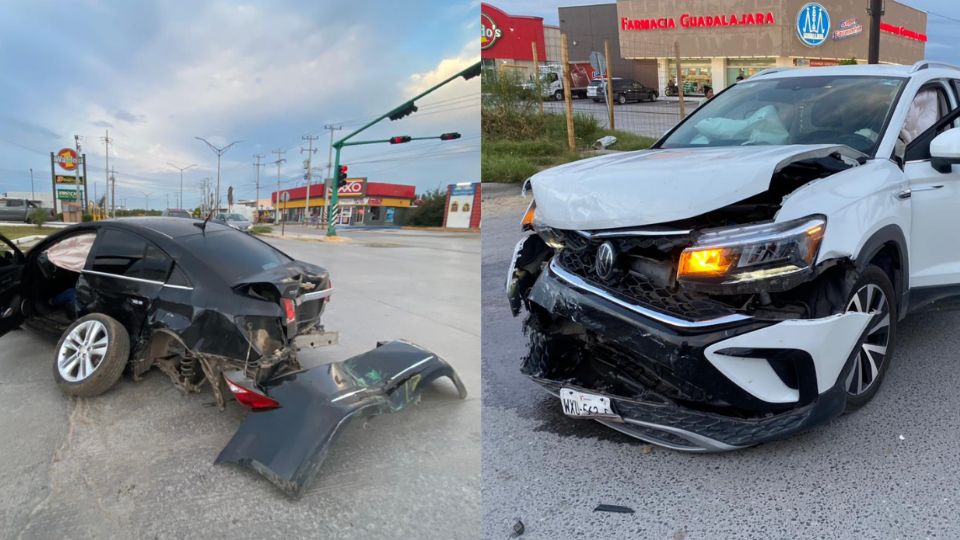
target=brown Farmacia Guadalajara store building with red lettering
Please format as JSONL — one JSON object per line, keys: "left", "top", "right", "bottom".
{"left": 615, "top": 0, "right": 927, "bottom": 95}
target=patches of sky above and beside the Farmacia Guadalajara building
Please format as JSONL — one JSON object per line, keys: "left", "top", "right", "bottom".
{"left": 490, "top": 0, "right": 960, "bottom": 65}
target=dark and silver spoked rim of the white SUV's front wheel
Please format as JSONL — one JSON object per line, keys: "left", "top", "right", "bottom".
{"left": 846, "top": 283, "right": 890, "bottom": 396}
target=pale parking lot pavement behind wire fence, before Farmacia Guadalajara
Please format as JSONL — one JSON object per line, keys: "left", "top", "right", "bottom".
{"left": 543, "top": 97, "right": 701, "bottom": 138}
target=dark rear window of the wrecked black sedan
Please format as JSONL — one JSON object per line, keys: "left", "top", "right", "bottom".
{"left": 182, "top": 230, "right": 293, "bottom": 283}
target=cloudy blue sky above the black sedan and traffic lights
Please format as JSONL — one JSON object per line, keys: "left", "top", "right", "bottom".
{"left": 0, "top": 0, "right": 480, "bottom": 208}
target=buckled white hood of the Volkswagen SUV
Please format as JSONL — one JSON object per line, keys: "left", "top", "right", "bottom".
{"left": 530, "top": 144, "right": 859, "bottom": 230}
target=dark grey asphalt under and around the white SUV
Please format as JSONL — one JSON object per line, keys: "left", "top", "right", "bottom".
{"left": 481, "top": 185, "right": 960, "bottom": 539}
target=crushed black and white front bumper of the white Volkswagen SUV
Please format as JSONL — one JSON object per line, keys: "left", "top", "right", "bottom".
{"left": 522, "top": 265, "right": 873, "bottom": 452}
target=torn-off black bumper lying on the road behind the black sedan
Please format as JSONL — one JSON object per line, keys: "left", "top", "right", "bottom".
{"left": 216, "top": 341, "right": 467, "bottom": 497}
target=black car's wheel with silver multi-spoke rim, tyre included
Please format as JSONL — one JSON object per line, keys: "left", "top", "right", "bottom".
{"left": 53, "top": 313, "right": 130, "bottom": 397}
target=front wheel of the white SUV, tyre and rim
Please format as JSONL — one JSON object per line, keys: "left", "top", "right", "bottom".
{"left": 844, "top": 265, "right": 897, "bottom": 410}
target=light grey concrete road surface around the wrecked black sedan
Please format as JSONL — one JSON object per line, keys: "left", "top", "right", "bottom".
{"left": 0, "top": 227, "right": 480, "bottom": 538}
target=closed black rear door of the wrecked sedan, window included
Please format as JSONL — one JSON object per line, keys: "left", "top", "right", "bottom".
{"left": 77, "top": 227, "right": 171, "bottom": 345}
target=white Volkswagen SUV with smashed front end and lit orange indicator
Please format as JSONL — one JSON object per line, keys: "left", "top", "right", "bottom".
{"left": 507, "top": 62, "right": 960, "bottom": 452}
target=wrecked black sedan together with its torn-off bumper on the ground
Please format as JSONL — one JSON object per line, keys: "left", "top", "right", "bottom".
{"left": 0, "top": 217, "right": 465, "bottom": 496}
